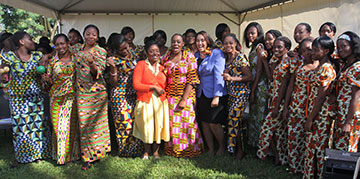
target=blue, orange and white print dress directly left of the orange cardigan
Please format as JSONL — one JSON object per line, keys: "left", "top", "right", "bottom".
{"left": 110, "top": 55, "right": 144, "bottom": 157}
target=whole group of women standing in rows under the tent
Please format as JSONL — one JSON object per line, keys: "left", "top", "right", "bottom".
{"left": 0, "top": 22, "right": 360, "bottom": 178}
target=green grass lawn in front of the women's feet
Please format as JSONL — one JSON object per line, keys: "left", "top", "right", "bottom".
{"left": 0, "top": 130, "right": 301, "bottom": 179}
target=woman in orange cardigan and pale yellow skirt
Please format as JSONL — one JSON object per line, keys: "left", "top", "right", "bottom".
{"left": 133, "top": 40, "right": 170, "bottom": 159}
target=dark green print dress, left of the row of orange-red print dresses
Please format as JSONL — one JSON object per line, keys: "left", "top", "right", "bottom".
{"left": 247, "top": 48, "right": 269, "bottom": 147}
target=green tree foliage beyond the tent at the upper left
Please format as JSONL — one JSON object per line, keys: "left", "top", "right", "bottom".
{"left": 0, "top": 4, "right": 55, "bottom": 42}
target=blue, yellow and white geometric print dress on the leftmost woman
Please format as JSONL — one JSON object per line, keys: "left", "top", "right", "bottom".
{"left": 3, "top": 52, "right": 51, "bottom": 163}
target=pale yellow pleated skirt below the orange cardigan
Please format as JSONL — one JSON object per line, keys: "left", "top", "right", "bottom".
{"left": 133, "top": 92, "right": 170, "bottom": 144}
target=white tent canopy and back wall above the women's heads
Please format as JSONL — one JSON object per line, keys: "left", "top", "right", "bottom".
{"left": 0, "top": 0, "right": 360, "bottom": 50}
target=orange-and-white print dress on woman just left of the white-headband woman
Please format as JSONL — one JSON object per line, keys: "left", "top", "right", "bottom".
{"left": 303, "top": 62, "right": 336, "bottom": 178}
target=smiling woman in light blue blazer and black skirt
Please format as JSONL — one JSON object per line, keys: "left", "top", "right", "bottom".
{"left": 195, "top": 31, "right": 227, "bottom": 155}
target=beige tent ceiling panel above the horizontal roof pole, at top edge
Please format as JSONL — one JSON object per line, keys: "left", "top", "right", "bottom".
{"left": 7, "top": 0, "right": 286, "bottom": 13}
